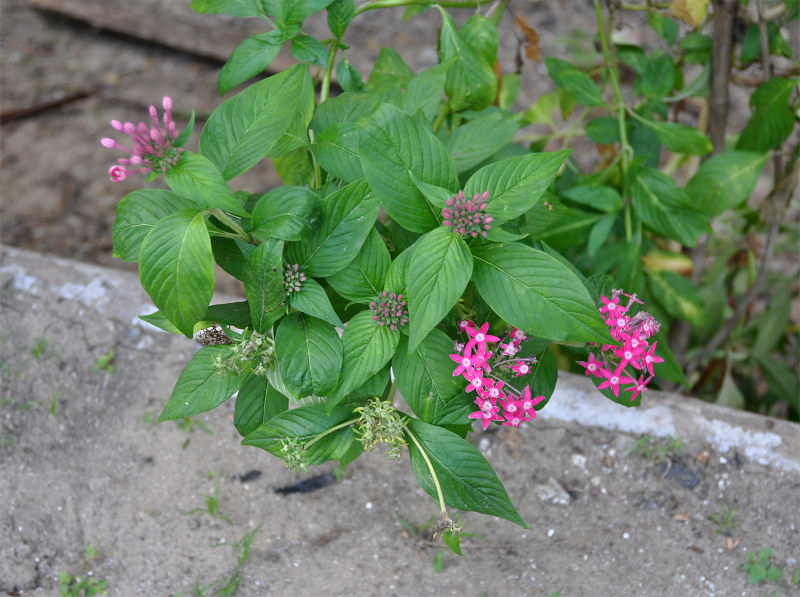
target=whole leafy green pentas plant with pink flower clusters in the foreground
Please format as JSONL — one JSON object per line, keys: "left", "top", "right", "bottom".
{"left": 103, "top": 0, "right": 672, "bottom": 552}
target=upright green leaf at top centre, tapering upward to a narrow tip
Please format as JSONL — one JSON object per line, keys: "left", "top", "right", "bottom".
{"left": 434, "top": 5, "right": 497, "bottom": 112}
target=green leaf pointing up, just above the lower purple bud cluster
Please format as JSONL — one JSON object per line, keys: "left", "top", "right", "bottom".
{"left": 327, "top": 228, "right": 392, "bottom": 302}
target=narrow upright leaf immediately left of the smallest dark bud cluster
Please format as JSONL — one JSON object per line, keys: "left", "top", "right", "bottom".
{"left": 243, "top": 239, "right": 286, "bottom": 334}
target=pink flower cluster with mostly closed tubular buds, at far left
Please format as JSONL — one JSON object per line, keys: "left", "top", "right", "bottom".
{"left": 100, "top": 96, "right": 183, "bottom": 182}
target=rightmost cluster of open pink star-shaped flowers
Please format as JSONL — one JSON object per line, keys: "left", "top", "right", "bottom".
{"left": 578, "top": 290, "right": 664, "bottom": 401}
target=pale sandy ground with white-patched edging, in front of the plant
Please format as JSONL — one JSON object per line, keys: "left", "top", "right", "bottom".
{"left": 0, "top": 247, "right": 800, "bottom": 597}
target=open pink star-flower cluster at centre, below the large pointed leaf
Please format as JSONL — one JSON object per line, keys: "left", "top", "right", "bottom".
{"left": 450, "top": 321, "right": 544, "bottom": 431}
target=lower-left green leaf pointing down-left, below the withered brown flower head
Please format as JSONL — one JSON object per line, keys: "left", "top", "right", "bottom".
{"left": 158, "top": 345, "right": 241, "bottom": 421}
